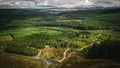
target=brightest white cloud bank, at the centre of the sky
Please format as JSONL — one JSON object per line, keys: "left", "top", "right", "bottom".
{"left": 37, "top": 0, "right": 92, "bottom": 7}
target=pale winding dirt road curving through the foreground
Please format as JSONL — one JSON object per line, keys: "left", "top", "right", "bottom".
{"left": 34, "top": 34, "right": 101, "bottom": 68}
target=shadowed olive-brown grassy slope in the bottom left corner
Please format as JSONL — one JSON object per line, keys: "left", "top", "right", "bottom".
{"left": 0, "top": 54, "right": 45, "bottom": 68}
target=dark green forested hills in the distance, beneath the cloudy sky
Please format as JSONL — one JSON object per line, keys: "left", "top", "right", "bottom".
{"left": 0, "top": 9, "right": 120, "bottom": 30}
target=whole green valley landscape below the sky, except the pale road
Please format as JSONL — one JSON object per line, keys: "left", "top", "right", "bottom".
{"left": 0, "top": 9, "right": 120, "bottom": 68}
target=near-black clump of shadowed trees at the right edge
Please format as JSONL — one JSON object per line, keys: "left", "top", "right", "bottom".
{"left": 87, "top": 40, "right": 120, "bottom": 62}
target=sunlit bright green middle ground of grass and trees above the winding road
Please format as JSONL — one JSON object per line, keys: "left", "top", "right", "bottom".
{"left": 0, "top": 27, "right": 119, "bottom": 56}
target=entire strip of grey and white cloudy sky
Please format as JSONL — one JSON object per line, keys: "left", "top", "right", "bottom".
{"left": 0, "top": 0, "right": 120, "bottom": 8}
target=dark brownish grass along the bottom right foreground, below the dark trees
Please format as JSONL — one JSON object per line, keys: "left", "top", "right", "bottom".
{"left": 57, "top": 59, "right": 120, "bottom": 68}
